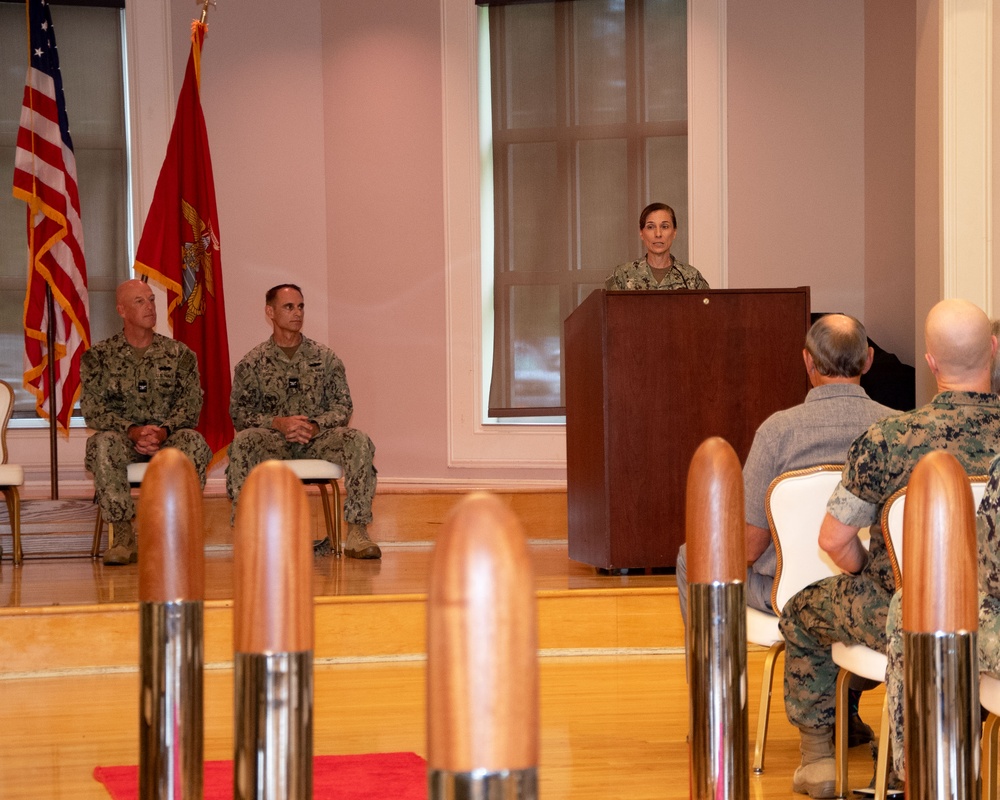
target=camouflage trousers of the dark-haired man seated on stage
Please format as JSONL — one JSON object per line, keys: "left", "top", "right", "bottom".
{"left": 226, "top": 428, "right": 376, "bottom": 525}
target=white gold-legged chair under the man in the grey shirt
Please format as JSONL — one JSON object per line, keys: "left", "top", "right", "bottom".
{"left": 747, "top": 464, "right": 843, "bottom": 773}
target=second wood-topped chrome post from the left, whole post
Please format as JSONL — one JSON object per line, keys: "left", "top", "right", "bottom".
{"left": 233, "top": 461, "right": 313, "bottom": 800}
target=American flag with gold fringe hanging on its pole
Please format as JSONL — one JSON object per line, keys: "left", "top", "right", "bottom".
{"left": 14, "top": 0, "right": 90, "bottom": 433}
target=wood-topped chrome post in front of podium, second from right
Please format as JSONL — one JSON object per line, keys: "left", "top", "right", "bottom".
{"left": 685, "top": 437, "right": 750, "bottom": 800}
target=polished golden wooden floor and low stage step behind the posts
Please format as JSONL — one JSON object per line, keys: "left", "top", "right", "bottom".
{"left": 0, "top": 494, "right": 882, "bottom": 800}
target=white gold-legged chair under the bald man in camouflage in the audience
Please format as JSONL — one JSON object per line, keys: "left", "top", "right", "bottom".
{"left": 830, "top": 475, "right": 986, "bottom": 800}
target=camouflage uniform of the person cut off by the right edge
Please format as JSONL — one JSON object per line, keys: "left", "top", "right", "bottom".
{"left": 886, "top": 458, "right": 1000, "bottom": 778}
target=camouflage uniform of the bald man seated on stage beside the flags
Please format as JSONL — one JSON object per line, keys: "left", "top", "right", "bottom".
{"left": 80, "top": 333, "right": 212, "bottom": 523}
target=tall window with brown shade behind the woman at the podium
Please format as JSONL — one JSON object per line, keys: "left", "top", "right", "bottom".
{"left": 480, "top": 0, "right": 688, "bottom": 418}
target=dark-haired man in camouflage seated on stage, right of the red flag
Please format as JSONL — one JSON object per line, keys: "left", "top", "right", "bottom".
{"left": 226, "top": 283, "right": 382, "bottom": 558}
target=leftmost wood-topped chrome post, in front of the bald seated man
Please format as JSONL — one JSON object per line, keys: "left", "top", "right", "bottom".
{"left": 137, "top": 448, "right": 205, "bottom": 800}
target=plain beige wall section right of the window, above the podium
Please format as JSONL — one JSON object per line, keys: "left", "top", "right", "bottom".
{"left": 727, "top": 0, "right": 865, "bottom": 328}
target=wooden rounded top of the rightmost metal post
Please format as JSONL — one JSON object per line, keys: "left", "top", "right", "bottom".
{"left": 903, "top": 452, "right": 979, "bottom": 633}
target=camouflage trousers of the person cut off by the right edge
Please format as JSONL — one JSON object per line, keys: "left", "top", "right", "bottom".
{"left": 886, "top": 592, "right": 1000, "bottom": 780}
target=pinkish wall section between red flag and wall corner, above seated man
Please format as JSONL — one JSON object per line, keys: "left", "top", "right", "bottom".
{"left": 179, "top": 0, "right": 330, "bottom": 344}
